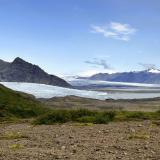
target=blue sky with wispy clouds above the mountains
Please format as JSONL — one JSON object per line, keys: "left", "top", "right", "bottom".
{"left": 0, "top": 0, "right": 160, "bottom": 76}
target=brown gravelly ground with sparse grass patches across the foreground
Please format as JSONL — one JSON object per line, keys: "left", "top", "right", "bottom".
{"left": 0, "top": 121, "right": 160, "bottom": 160}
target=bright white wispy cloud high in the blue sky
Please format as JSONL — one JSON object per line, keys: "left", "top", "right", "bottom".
{"left": 91, "top": 22, "right": 137, "bottom": 41}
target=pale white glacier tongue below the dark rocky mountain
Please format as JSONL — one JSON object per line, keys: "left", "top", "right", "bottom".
{"left": 0, "top": 82, "right": 108, "bottom": 100}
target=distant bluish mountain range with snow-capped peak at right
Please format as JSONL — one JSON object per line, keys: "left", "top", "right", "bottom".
{"left": 84, "top": 69, "right": 160, "bottom": 84}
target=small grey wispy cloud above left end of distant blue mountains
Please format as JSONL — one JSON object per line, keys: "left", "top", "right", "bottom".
{"left": 85, "top": 58, "right": 111, "bottom": 69}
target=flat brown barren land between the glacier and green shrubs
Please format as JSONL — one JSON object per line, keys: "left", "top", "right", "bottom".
{"left": 40, "top": 96, "right": 160, "bottom": 112}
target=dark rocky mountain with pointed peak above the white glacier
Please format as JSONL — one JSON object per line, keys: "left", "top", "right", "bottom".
{"left": 0, "top": 57, "right": 71, "bottom": 87}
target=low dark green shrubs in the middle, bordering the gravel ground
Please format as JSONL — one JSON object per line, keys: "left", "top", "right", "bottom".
{"left": 34, "top": 109, "right": 115, "bottom": 124}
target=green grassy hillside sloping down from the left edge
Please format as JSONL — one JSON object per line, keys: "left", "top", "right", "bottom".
{"left": 0, "top": 85, "right": 47, "bottom": 121}
